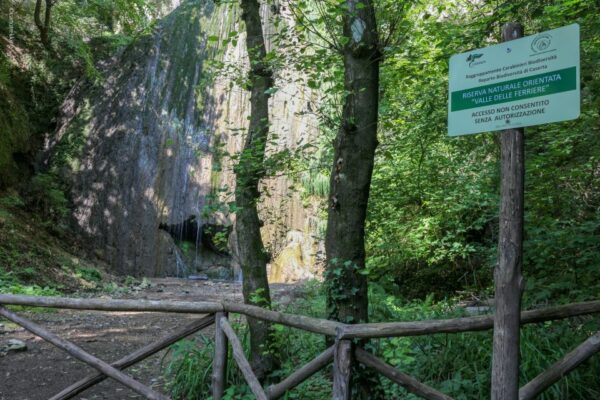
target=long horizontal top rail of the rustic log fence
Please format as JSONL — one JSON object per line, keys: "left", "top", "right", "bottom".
{"left": 0, "top": 294, "right": 600, "bottom": 339}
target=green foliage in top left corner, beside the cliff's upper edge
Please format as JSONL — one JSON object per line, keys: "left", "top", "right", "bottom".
{"left": 0, "top": 0, "right": 168, "bottom": 188}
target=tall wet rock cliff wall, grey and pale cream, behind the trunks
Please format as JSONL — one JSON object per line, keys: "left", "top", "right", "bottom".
{"left": 46, "top": 1, "right": 319, "bottom": 281}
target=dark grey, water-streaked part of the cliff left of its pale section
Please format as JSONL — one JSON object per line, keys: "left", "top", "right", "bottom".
{"left": 48, "top": 1, "right": 218, "bottom": 276}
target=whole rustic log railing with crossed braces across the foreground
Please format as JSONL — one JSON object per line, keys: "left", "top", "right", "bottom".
{"left": 0, "top": 294, "right": 600, "bottom": 400}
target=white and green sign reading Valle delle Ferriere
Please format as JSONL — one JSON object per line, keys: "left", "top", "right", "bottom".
{"left": 448, "top": 24, "right": 580, "bottom": 136}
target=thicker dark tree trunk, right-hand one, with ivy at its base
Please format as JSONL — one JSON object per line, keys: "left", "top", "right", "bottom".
{"left": 325, "top": 0, "right": 381, "bottom": 398}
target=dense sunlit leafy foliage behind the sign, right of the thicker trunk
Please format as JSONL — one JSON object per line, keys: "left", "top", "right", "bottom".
{"left": 367, "top": 0, "right": 600, "bottom": 302}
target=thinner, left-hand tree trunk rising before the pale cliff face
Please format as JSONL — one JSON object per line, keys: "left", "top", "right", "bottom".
{"left": 235, "top": 0, "right": 274, "bottom": 380}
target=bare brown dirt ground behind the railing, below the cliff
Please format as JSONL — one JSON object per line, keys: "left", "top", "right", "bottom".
{"left": 0, "top": 279, "right": 295, "bottom": 400}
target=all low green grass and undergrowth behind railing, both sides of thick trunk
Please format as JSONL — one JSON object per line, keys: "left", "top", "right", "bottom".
{"left": 166, "top": 283, "right": 600, "bottom": 400}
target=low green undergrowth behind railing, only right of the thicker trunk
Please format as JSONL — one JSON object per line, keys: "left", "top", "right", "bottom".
{"left": 370, "top": 286, "right": 600, "bottom": 400}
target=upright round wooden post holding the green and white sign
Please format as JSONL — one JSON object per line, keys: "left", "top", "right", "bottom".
{"left": 492, "top": 23, "right": 525, "bottom": 400}
